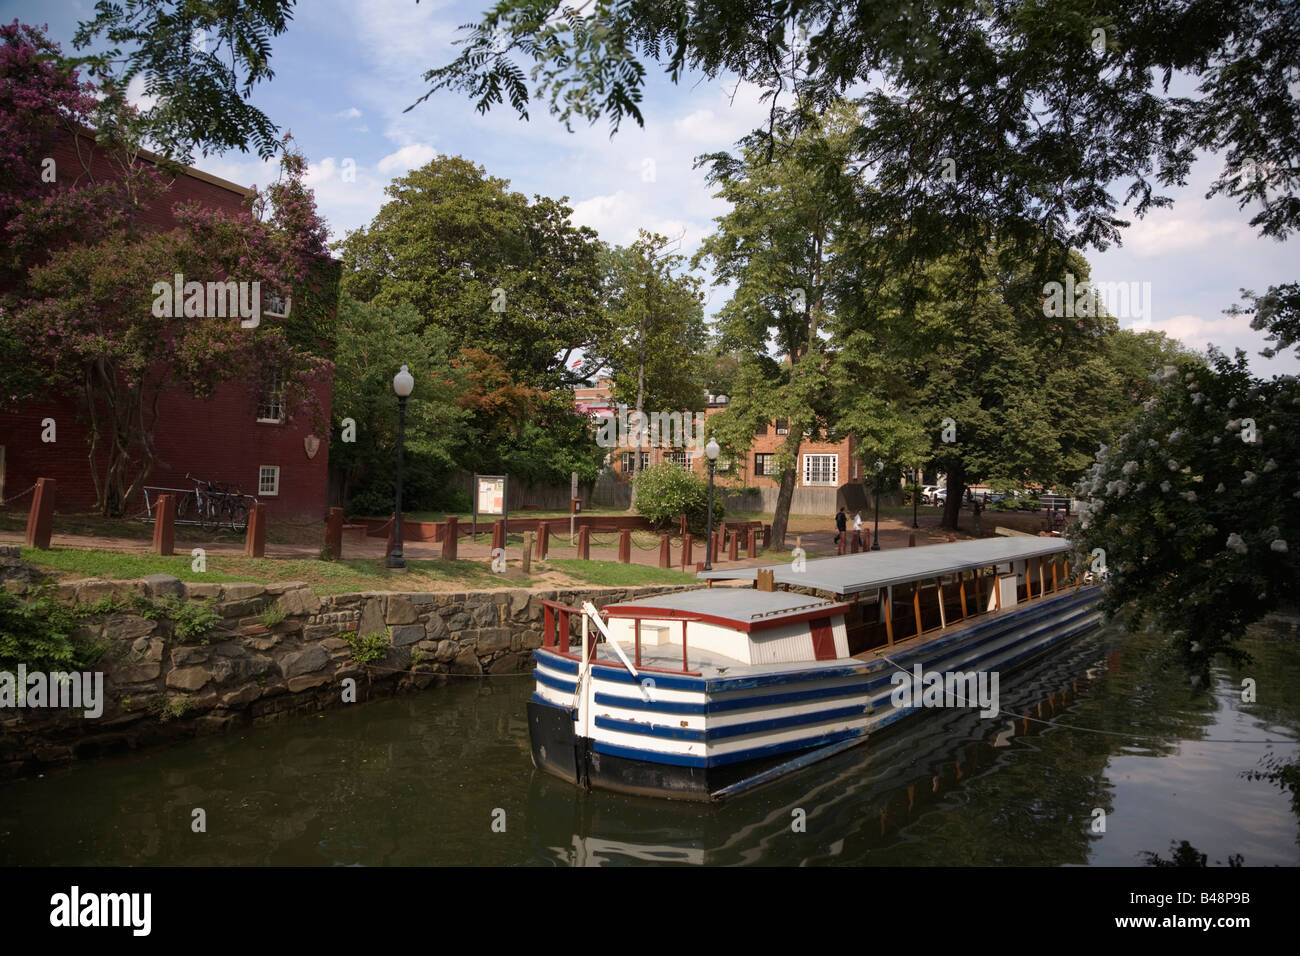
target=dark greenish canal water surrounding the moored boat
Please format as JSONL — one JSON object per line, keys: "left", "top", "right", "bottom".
{"left": 0, "top": 627, "right": 1300, "bottom": 866}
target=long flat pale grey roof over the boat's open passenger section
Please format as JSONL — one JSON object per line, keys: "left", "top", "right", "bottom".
{"left": 696, "top": 536, "right": 1073, "bottom": 594}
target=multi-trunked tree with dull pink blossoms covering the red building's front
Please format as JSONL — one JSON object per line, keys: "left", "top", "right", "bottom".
{"left": 0, "top": 140, "right": 334, "bottom": 514}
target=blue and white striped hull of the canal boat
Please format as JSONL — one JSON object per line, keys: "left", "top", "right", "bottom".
{"left": 529, "top": 587, "right": 1100, "bottom": 800}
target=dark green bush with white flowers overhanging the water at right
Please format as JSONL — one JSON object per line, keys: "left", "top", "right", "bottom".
{"left": 1076, "top": 350, "right": 1300, "bottom": 654}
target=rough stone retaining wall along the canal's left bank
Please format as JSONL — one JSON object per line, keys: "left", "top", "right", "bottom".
{"left": 0, "top": 549, "right": 691, "bottom": 774}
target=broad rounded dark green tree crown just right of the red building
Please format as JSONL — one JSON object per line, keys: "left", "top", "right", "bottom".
{"left": 339, "top": 156, "right": 608, "bottom": 388}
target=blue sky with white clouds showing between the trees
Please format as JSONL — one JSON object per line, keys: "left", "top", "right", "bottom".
{"left": 0, "top": 0, "right": 1300, "bottom": 376}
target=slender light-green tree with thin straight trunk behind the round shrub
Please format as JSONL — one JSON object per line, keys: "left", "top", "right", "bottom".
{"left": 598, "top": 229, "right": 707, "bottom": 509}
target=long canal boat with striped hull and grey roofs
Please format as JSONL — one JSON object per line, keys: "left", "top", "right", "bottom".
{"left": 528, "top": 537, "right": 1100, "bottom": 801}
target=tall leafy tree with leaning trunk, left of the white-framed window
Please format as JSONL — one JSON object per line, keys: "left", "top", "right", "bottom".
{"left": 694, "top": 107, "right": 854, "bottom": 548}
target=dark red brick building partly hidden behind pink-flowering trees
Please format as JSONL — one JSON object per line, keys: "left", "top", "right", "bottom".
{"left": 0, "top": 135, "right": 333, "bottom": 518}
